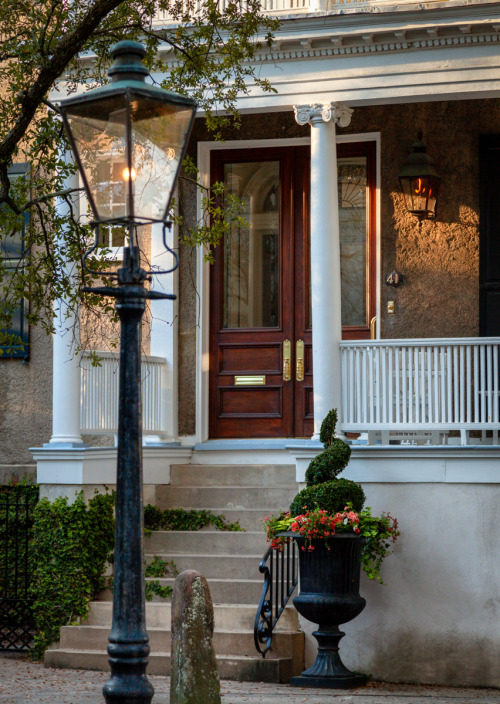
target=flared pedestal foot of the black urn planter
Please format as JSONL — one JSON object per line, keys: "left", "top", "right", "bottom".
{"left": 290, "top": 626, "right": 368, "bottom": 689}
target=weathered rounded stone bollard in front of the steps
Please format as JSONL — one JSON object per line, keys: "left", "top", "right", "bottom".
{"left": 170, "top": 570, "right": 221, "bottom": 704}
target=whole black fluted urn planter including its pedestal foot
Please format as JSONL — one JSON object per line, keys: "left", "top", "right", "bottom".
{"left": 290, "top": 533, "right": 367, "bottom": 689}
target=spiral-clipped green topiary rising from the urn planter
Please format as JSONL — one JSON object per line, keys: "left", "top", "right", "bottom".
{"left": 290, "top": 408, "right": 366, "bottom": 516}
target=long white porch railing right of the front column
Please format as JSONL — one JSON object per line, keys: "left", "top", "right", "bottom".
{"left": 340, "top": 338, "right": 500, "bottom": 432}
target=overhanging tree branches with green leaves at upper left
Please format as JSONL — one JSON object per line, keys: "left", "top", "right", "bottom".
{"left": 0, "top": 0, "right": 279, "bottom": 344}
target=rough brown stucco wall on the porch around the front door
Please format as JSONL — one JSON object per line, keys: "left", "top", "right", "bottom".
{"left": 179, "top": 100, "right": 500, "bottom": 435}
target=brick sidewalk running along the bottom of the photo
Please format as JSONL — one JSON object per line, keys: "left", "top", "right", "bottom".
{"left": 0, "top": 654, "right": 500, "bottom": 704}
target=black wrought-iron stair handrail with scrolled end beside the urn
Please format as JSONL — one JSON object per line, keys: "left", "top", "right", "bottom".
{"left": 253, "top": 533, "right": 299, "bottom": 658}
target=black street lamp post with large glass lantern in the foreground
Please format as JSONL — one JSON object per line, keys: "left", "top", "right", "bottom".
{"left": 61, "top": 41, "right": 196, "bottom": 704}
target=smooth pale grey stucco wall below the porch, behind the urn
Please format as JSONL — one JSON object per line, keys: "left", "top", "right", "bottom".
{"left": 303, "top": 484, "right": 500, "bottom": 687}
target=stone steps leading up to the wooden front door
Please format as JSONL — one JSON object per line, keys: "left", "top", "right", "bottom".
{"left": 45, "top": 465, "right": 304, "bottom": 682}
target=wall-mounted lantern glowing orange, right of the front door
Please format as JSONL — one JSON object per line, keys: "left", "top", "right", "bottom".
{"left": 399, "top": 130, "right": 441, "bottom": 220}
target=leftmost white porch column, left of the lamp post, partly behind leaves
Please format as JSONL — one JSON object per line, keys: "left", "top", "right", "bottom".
{"left": 50, "top": 154, "right": 83, "bottom": 447}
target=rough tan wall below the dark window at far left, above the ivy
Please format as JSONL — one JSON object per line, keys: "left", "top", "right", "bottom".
{"left": 0, "top": 328, "right": 52, "bottom": 465}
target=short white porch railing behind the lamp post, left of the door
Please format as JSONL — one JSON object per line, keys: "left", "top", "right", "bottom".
{"left": 80, "top": 352, "right": 166, "bottom": 435}
